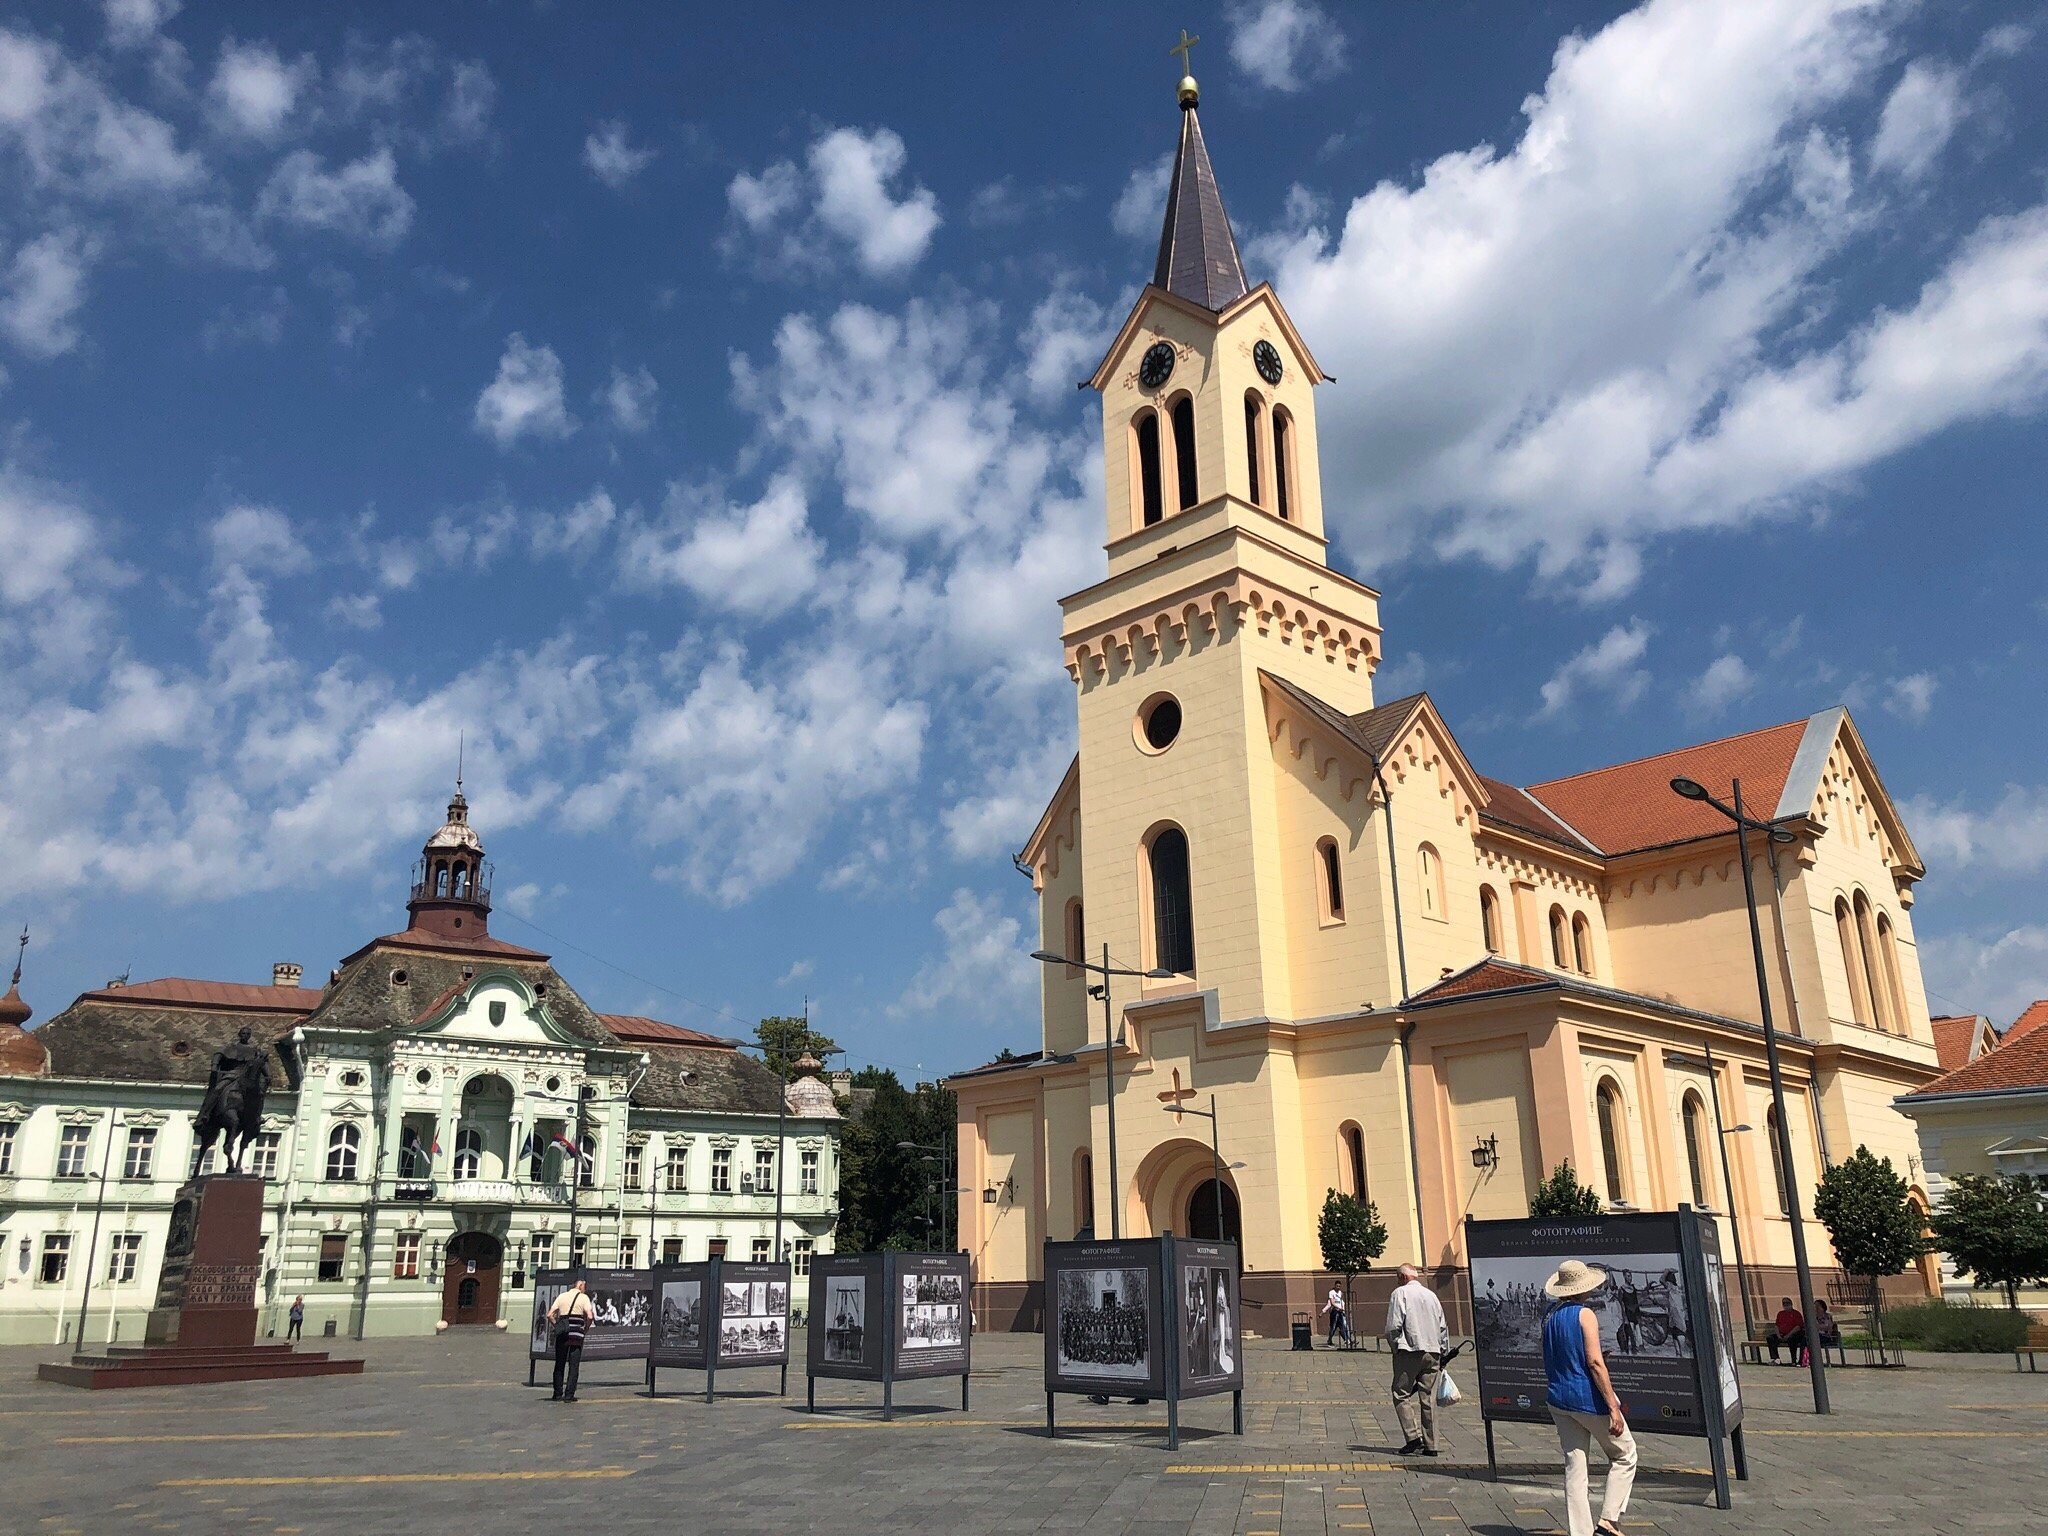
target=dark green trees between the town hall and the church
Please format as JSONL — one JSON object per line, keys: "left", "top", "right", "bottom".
{"left": 836, "top": 1069, "right": 954, "bottom": 1253}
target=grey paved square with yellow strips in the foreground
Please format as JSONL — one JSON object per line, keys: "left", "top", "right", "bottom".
{"left": 0, "top": 1331, "right": 2048, "bottom": 1536}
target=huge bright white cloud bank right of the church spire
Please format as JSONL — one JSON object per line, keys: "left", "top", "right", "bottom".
{"left": 1251, "top": 0, "right": 2048, "bottom": 598}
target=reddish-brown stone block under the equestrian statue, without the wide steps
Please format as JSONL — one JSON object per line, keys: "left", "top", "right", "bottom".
{"left": 143, "top": 1174, "right": 262, "bottom": 1350}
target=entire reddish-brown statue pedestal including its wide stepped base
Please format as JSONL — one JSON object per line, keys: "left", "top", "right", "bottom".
{"left": 37, "top": 1174, "right": 362, "bottom": 1389}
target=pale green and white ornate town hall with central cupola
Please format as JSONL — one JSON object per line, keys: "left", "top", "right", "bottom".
{"left": 0, "top": 791, "right": 840, "bottom": 1343}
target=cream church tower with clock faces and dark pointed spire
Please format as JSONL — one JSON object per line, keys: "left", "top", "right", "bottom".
{"left": 1047, "top": 66, "right": 1380, "bottom": 1049}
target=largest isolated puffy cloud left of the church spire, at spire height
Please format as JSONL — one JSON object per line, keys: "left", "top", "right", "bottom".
{"left": 725, "top": 129, "right": 940, "bottom": 276}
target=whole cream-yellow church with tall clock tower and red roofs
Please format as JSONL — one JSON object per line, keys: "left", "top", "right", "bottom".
{"left": 952, "top": 82, "right": 1937, "bottom": 1331}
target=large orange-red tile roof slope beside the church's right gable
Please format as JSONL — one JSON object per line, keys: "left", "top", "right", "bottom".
{"left": 1528, "top": 721, "right": 1806, "bottom": 854}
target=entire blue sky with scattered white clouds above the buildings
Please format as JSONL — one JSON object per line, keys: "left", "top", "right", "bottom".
{"left": 0, "top": 0, "right": 2048, "bottom": 1073}
